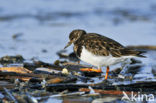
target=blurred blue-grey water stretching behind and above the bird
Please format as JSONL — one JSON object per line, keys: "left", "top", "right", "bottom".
{"left": 0, "top": 0, "right": 156, "bottom": 62}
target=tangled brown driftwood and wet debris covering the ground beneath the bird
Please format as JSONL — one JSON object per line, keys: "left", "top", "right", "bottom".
{"left": 0, "top": 46, "right": 156, "bottom": 103}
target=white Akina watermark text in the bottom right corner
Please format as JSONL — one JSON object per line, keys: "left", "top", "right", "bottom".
{"left": 121, "top": 91, "right": 154, "bottom": 101}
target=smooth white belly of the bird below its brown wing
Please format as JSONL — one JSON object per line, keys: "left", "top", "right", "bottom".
{"left": 80, "top": 47, "right": 133, "bottom": 67}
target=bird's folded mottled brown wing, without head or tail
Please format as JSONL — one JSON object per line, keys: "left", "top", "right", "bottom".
{"left": 83, "top": 33, "right": 124, "bottom": 57}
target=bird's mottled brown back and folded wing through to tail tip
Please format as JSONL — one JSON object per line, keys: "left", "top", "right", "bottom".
{"left": 79, "top": 33, "right": 144, "bottom": 57}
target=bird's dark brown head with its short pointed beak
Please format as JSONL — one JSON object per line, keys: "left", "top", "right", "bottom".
{"left": 64, "top": 29, "right": 86, "bottom": 49}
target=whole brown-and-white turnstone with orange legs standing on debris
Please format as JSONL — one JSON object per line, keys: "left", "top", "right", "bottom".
{"left": 65, "top": 29, "right": 144, "bottom": 79}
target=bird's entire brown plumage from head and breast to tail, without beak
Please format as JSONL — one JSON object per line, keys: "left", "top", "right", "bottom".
{"left": 64, "top": 30, "right": 143, "bottom": 57}
